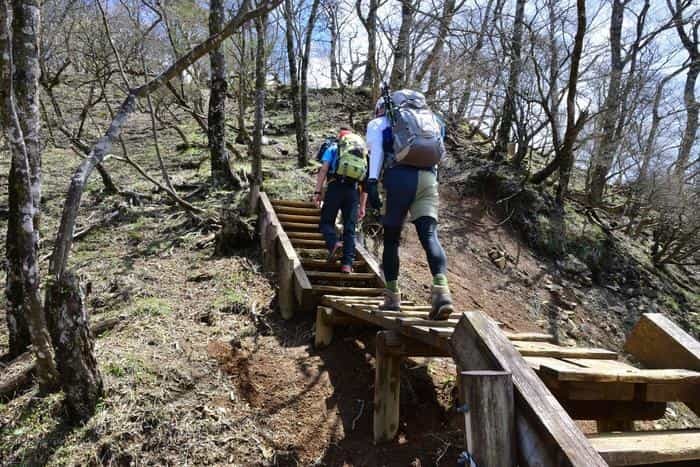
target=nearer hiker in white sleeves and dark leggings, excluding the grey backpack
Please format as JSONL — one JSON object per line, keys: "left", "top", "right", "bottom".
{"left": 366, "top": 91, "right": 453, "bottom": 319}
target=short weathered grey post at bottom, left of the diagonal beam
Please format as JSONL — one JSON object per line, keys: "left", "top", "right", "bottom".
{"left": 459, "top": 371, "right": 516, "bottom": 467}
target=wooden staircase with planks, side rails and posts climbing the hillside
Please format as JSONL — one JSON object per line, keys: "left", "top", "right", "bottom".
{"left": 258, "top": 193, "right": 700, "bottom": 467}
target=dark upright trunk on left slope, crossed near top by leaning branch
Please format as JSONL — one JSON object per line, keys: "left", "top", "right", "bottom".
{"left": 207, "top": 0, "right": 240, "bottom": 188}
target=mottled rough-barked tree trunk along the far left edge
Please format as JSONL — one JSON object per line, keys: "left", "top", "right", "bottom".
{"left": 0, "top": 0, "right": 56, "bottom": 392}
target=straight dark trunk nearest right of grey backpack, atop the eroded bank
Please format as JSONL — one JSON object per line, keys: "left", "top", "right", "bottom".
{"left": 494, "top": 0, "right": 526, "bottom": 159}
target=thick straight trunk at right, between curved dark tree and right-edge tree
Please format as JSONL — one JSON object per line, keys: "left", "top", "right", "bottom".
{"left": 588, "top": 0, "right": 625, "bottom": 206}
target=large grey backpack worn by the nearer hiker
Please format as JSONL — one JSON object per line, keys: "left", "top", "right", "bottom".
{"left": 391, "top": 89, "right": 445, "bottom": 169}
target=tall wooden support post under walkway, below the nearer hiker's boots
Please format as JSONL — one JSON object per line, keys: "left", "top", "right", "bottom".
{"left": 374, "top": 331, "right": 401, "bottom": 444}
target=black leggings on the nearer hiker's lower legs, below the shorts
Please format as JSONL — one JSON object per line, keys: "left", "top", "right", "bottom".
{"left": 382, "top": 216, "right": 447, "bottom": 281}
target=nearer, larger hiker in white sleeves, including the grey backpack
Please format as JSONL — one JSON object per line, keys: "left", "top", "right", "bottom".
{"left": 366, "top": 87, "right": 453, "bottom": 320}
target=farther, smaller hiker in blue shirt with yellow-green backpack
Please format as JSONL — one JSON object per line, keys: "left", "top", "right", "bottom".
{"left": 314, "top": 128, "right": 367, "bottom": 274}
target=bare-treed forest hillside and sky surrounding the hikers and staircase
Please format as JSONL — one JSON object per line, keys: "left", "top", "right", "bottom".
{"left": 0, "top": 0, "right": 700, "bottom": 465}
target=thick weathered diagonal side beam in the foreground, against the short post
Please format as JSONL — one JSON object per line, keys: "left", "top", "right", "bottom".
{"left": 450, "top": 312, "right": 607, "bottom": 467}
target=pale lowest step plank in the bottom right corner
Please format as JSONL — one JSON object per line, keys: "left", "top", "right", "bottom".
{"left": 589, "top": 430, "right": 700, "bottom": 466}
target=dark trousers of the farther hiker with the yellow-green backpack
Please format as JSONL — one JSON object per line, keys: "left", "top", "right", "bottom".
{"left": 319, "top": 180, "right": 360, "bottom": 265}
